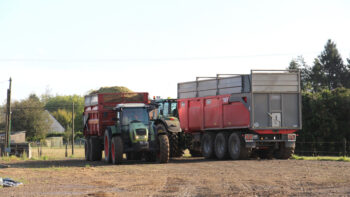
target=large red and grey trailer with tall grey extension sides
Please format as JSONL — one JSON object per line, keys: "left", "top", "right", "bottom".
{"left": 178, "top": 70, "right": 301, "bottom": 159}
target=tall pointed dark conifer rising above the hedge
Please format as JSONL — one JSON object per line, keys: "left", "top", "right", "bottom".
{"left": 310, "top": 40, "right": 349, "bottom": 91}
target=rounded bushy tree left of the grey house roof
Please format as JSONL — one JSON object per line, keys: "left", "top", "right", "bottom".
{"left": 12, "top": 94, "right": 51, "bottom": 141}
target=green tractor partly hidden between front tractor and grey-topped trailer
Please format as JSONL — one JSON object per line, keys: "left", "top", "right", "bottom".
{"left": 151, "top": 99, "right": 185, "bottom": 157}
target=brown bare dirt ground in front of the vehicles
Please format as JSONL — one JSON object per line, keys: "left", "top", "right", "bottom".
{"left": 0, "top": 158, "right": 350, "bottom": 196}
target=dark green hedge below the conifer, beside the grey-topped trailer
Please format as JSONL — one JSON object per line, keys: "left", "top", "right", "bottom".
{"left": 297, "top": 88, "right": 350, "bottom": 153}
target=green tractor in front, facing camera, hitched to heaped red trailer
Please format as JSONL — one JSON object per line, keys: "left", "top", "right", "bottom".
{"left": 103, "top": 103, "right": 170, "bottom": 164}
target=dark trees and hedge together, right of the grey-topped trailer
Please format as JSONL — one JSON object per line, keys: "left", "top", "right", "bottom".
{"left": 288, "top": 40, "right": 350, "bottom": 155}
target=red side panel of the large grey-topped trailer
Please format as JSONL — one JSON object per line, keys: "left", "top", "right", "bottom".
{"left": 178, "top": 95, "right": 250, "bottom": 133}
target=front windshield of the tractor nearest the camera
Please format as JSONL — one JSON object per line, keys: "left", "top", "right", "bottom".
{"left": 122, "top": 107, "right": 149, "bottom": 125}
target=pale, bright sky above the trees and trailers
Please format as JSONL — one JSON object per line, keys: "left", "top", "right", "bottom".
{"left": 0, "top": 0, "right": 350, "bottom": 104}
